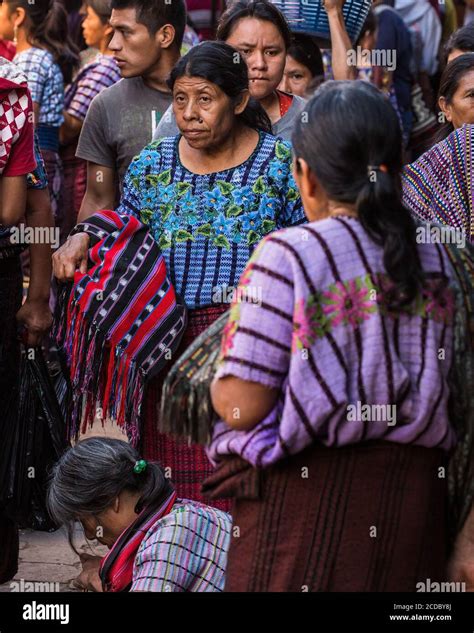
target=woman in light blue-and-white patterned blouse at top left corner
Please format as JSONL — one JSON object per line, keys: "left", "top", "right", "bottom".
{"left": 0, "top": 0, "right": 79, "bottom": 232}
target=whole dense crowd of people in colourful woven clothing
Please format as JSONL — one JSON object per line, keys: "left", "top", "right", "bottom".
{"left": 0, "top": 0, "right": 474, "bottom": 592}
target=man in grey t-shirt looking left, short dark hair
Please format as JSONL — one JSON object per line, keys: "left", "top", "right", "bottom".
{"left": 77, "top": 0, "right": 186, "bottom": 221}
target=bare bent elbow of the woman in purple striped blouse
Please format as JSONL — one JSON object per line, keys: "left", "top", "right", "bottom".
{"left": 211, "top": 376, "right": 279, "bottom": 431}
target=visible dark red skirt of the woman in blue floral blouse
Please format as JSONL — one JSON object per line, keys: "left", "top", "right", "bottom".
{"left": 142, "top": 305, "right": 231, "bottom": 511}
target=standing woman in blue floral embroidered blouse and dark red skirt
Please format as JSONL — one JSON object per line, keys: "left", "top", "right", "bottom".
{"left": 119, "top": 42, "right": 304, "bottom": 508}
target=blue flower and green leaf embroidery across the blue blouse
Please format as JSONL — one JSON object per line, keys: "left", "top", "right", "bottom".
{"left": 124, "top": 141, "right": 299, "bottom": 250}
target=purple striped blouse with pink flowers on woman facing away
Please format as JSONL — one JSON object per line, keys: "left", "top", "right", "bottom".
{"left": 208, "top": 218, "right": 455, "bottom": 466}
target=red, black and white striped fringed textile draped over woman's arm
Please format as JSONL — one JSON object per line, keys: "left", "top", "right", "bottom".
{"left": 54, "top": 211, "right": 186, "bottom": 446}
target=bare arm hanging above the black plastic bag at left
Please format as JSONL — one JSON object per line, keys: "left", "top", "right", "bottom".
{"left": 17, "top": 189, "right": 54, "bottom": 347}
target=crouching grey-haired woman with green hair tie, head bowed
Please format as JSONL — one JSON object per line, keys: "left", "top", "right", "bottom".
{"left": 47, "top": 438, "right": 232, "bottom": 592}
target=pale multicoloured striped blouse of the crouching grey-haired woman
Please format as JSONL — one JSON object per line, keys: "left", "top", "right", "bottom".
{"left": 131, "top": 499, "right": 232, "bottom": 592}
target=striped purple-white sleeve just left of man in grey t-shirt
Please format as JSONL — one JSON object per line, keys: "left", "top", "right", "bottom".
{"left": 65, "top": 54, "right": 121, "bottom": 121}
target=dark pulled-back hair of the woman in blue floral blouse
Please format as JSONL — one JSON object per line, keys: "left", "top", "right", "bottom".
{"left": 168, "top": 42, "right": 272, "bottom": 133}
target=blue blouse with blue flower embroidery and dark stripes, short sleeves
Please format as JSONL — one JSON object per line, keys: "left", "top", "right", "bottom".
{"left": 118, "top": 132, "right": 305, "bottom": 309}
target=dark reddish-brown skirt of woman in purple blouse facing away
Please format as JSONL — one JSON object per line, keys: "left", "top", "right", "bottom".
{"left": 204, "top": 442, "right": 447, "bottom": 592}
